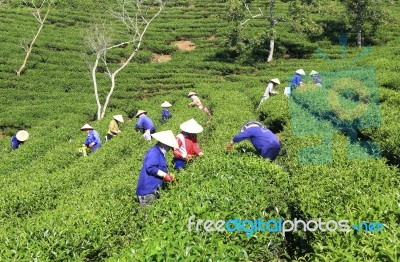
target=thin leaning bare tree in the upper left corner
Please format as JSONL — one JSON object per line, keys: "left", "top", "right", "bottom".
{"left": 17, "top": 0, "right": 51, "bottom": 76}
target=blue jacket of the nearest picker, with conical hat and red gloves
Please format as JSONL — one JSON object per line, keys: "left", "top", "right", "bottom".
{"left": 136, "top": 145, "right": 168, "bottom": 196}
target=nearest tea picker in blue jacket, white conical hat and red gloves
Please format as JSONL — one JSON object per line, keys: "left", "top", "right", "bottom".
{"left": 136, "top": 130, "right": 178, "bottom": 207}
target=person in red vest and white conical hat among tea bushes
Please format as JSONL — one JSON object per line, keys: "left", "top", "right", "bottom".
{"left": 173, "top": 119, "right": 203, "bottom": 170}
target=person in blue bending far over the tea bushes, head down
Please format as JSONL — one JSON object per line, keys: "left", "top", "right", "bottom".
{"left": 226, "top": 121, "right": 281, "bottom": 160}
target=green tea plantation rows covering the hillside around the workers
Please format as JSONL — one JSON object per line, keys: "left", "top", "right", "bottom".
{"left": 0, "top": 0, "right": 400, "bottom": 261}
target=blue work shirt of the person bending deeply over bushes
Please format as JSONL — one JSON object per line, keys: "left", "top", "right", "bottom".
{"left": 232, "top": 126, "right": 281, "bottom": 158}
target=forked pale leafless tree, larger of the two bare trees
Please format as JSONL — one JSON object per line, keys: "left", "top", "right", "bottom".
{"left": 85, "top": 0, "right": 168, "bottom": 120}
